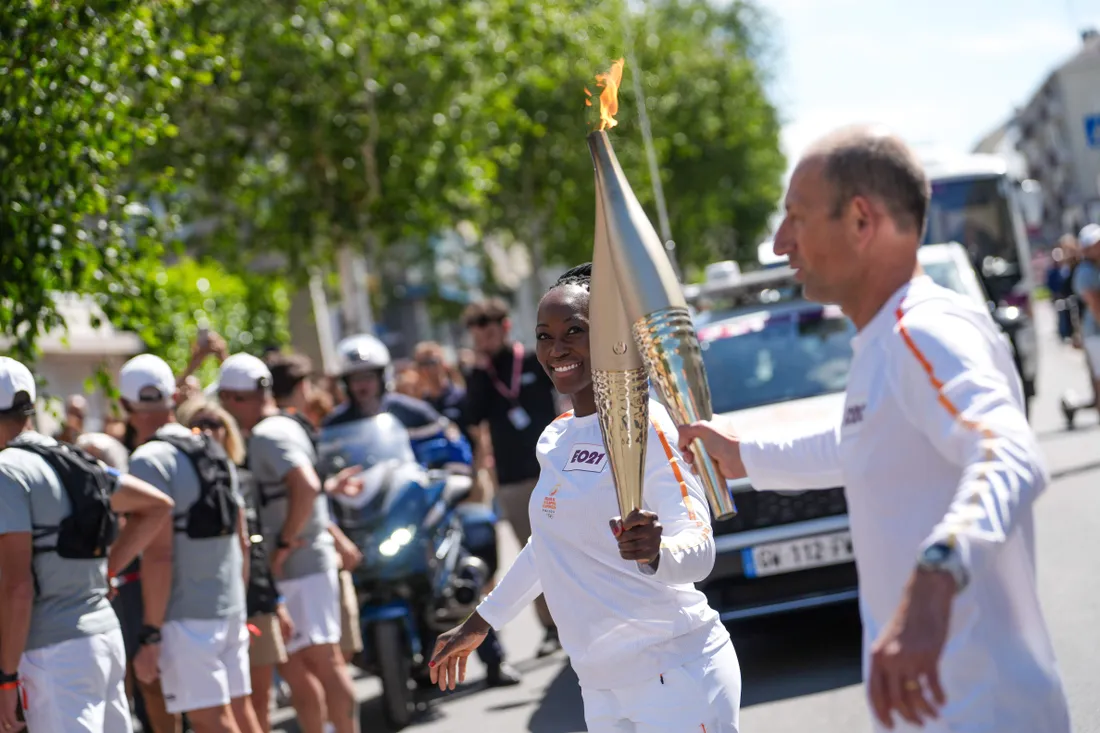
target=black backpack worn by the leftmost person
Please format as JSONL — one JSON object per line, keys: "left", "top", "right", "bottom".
{"left": 9, "top": 441, "right": 119, "bottom": 560}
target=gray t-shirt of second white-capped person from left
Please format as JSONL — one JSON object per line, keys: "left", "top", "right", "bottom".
{"left": 130, "top": 423, "right": 244, "bottom": 621}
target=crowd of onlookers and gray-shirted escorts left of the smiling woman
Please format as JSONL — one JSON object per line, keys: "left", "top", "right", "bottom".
{"left": 0, "top": 292, "right": 560, "bottom": 733}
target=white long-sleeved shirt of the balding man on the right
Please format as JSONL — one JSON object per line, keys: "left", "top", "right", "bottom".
{"left": 741, "top": 276, "right": 1069, "bottom": 733}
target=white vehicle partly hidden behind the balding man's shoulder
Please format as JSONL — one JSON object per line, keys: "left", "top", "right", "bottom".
{"left": 917, "top": 242, "right": 1038, "bottom": 413}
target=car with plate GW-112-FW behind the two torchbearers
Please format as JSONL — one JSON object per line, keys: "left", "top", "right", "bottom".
{"left": 688, "top": 267, "right": 858, "bottom": 621}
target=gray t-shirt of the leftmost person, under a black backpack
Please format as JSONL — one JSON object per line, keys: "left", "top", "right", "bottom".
{"left": 0, "top": 433, "right": 119, "bottom": 652}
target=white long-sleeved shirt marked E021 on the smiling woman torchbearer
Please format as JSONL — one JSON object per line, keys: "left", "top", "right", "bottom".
{"left": 477, "top": 401, "right": 729, "bottom": 689}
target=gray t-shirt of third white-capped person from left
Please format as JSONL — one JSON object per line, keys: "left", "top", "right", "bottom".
{"left": 249, "top": 415, "right": 337, "bottom": 580}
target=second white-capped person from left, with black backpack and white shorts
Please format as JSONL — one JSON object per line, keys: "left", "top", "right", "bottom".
{"left": 119, "top": 354, "right": 260, "bottom": 733}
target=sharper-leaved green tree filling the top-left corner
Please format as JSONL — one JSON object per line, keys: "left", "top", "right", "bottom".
{"left": 0, "top": 0, "right": 222, "bottom": 359}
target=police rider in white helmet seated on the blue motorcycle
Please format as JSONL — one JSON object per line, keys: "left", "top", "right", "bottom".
{"left": 322, "top": 333, "right": 520, "bottom": 687}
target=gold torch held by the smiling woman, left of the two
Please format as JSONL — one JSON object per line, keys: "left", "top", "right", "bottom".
{"left": 589, "top": 179, "right": 649, "bottom": 517}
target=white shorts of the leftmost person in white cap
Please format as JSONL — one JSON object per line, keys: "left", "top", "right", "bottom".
{"left": 19, "top": 628, "right": 133, "bottom": 733}
